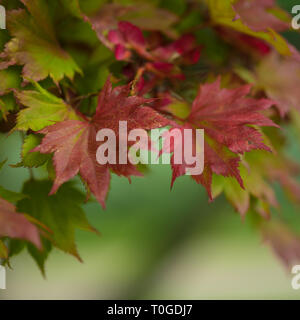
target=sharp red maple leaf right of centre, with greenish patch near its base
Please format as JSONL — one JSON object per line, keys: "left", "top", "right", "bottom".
{"left": 162, "top": 78, "right": 276, "bottom": 199}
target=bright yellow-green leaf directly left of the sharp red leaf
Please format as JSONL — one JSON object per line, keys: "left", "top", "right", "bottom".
{"left": 15, "top": 83, "right": 78, "bottom": 131}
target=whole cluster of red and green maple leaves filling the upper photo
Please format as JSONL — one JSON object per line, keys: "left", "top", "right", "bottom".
{"left": 0, "top": 0, "right": 300, "bottom": 272}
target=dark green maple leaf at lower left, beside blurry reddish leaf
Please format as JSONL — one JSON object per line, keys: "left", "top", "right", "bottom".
{"left": 17, "top": 180, "right": 97, "bottom": 266}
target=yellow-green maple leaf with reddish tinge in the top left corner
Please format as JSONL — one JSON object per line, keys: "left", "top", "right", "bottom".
{"left": 4, "top": 0, "right": 81, "bottom": 83}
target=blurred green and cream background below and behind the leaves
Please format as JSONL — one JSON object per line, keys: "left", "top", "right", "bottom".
{"left": 0, "top": 0, "right": 300, "bottom": 299}
